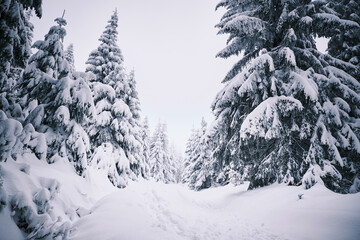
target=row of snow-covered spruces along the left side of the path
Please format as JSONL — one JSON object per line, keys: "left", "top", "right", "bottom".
{"left": 0, "top": 1, "right": 183, "bottom": 187}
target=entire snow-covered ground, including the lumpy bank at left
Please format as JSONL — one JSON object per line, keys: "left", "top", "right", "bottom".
{"left": 0, "top": 154, "right": 360, "bottom": 240}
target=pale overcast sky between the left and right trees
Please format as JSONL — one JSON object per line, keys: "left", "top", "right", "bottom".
{"left": 32, "top": 0, "right": 235, "bottom": 150}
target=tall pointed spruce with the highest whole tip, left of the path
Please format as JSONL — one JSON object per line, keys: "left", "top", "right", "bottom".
{"left": 86, "top": 11, "right": 143, "bottom": 187}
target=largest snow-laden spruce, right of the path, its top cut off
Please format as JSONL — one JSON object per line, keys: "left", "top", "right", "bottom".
{"left": 209, "top": 0, "right": 360, "bottom": 192}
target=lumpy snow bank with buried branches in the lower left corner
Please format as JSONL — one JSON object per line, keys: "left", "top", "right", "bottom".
{"left": 0, "top": 153, "right": 116, "bottom": 240}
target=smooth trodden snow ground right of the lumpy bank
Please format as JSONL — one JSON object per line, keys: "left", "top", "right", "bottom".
{"left": 70, "top": 181, "right": 360, "bottom": 240}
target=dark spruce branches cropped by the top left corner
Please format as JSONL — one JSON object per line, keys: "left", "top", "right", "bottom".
{"left": 0, "top": 0, "right": 42, "bottom": 92}
